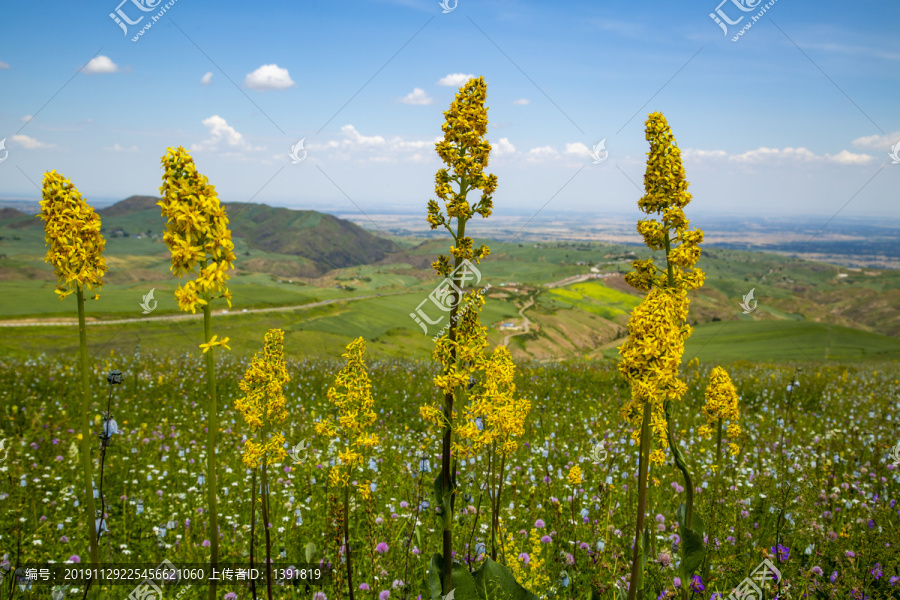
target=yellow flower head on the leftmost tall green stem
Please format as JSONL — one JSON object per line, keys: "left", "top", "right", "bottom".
{"left": 38, "top": 171, "right": 107, "bottom": 300}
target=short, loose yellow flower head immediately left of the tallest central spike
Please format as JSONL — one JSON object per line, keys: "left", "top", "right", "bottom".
{"left": 315, "top": 337, "right": 379, "bottom": 487}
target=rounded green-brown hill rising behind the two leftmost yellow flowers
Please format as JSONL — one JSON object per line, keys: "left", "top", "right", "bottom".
{"left": 0, "top": 196, "right": 393, "bottom": 275}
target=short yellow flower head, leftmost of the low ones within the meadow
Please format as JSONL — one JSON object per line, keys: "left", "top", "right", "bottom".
{"left": 234, "top": 329, "right": 291, "bottom": 468}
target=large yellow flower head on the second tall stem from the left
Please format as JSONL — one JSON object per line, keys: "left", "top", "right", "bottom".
{"left": 158, "top": 146, "right": 235, "bottom": 313}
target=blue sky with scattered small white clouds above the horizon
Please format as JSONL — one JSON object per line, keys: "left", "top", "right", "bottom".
{"left": 0, "top": 0, "right": 900, "bottom": 218}
